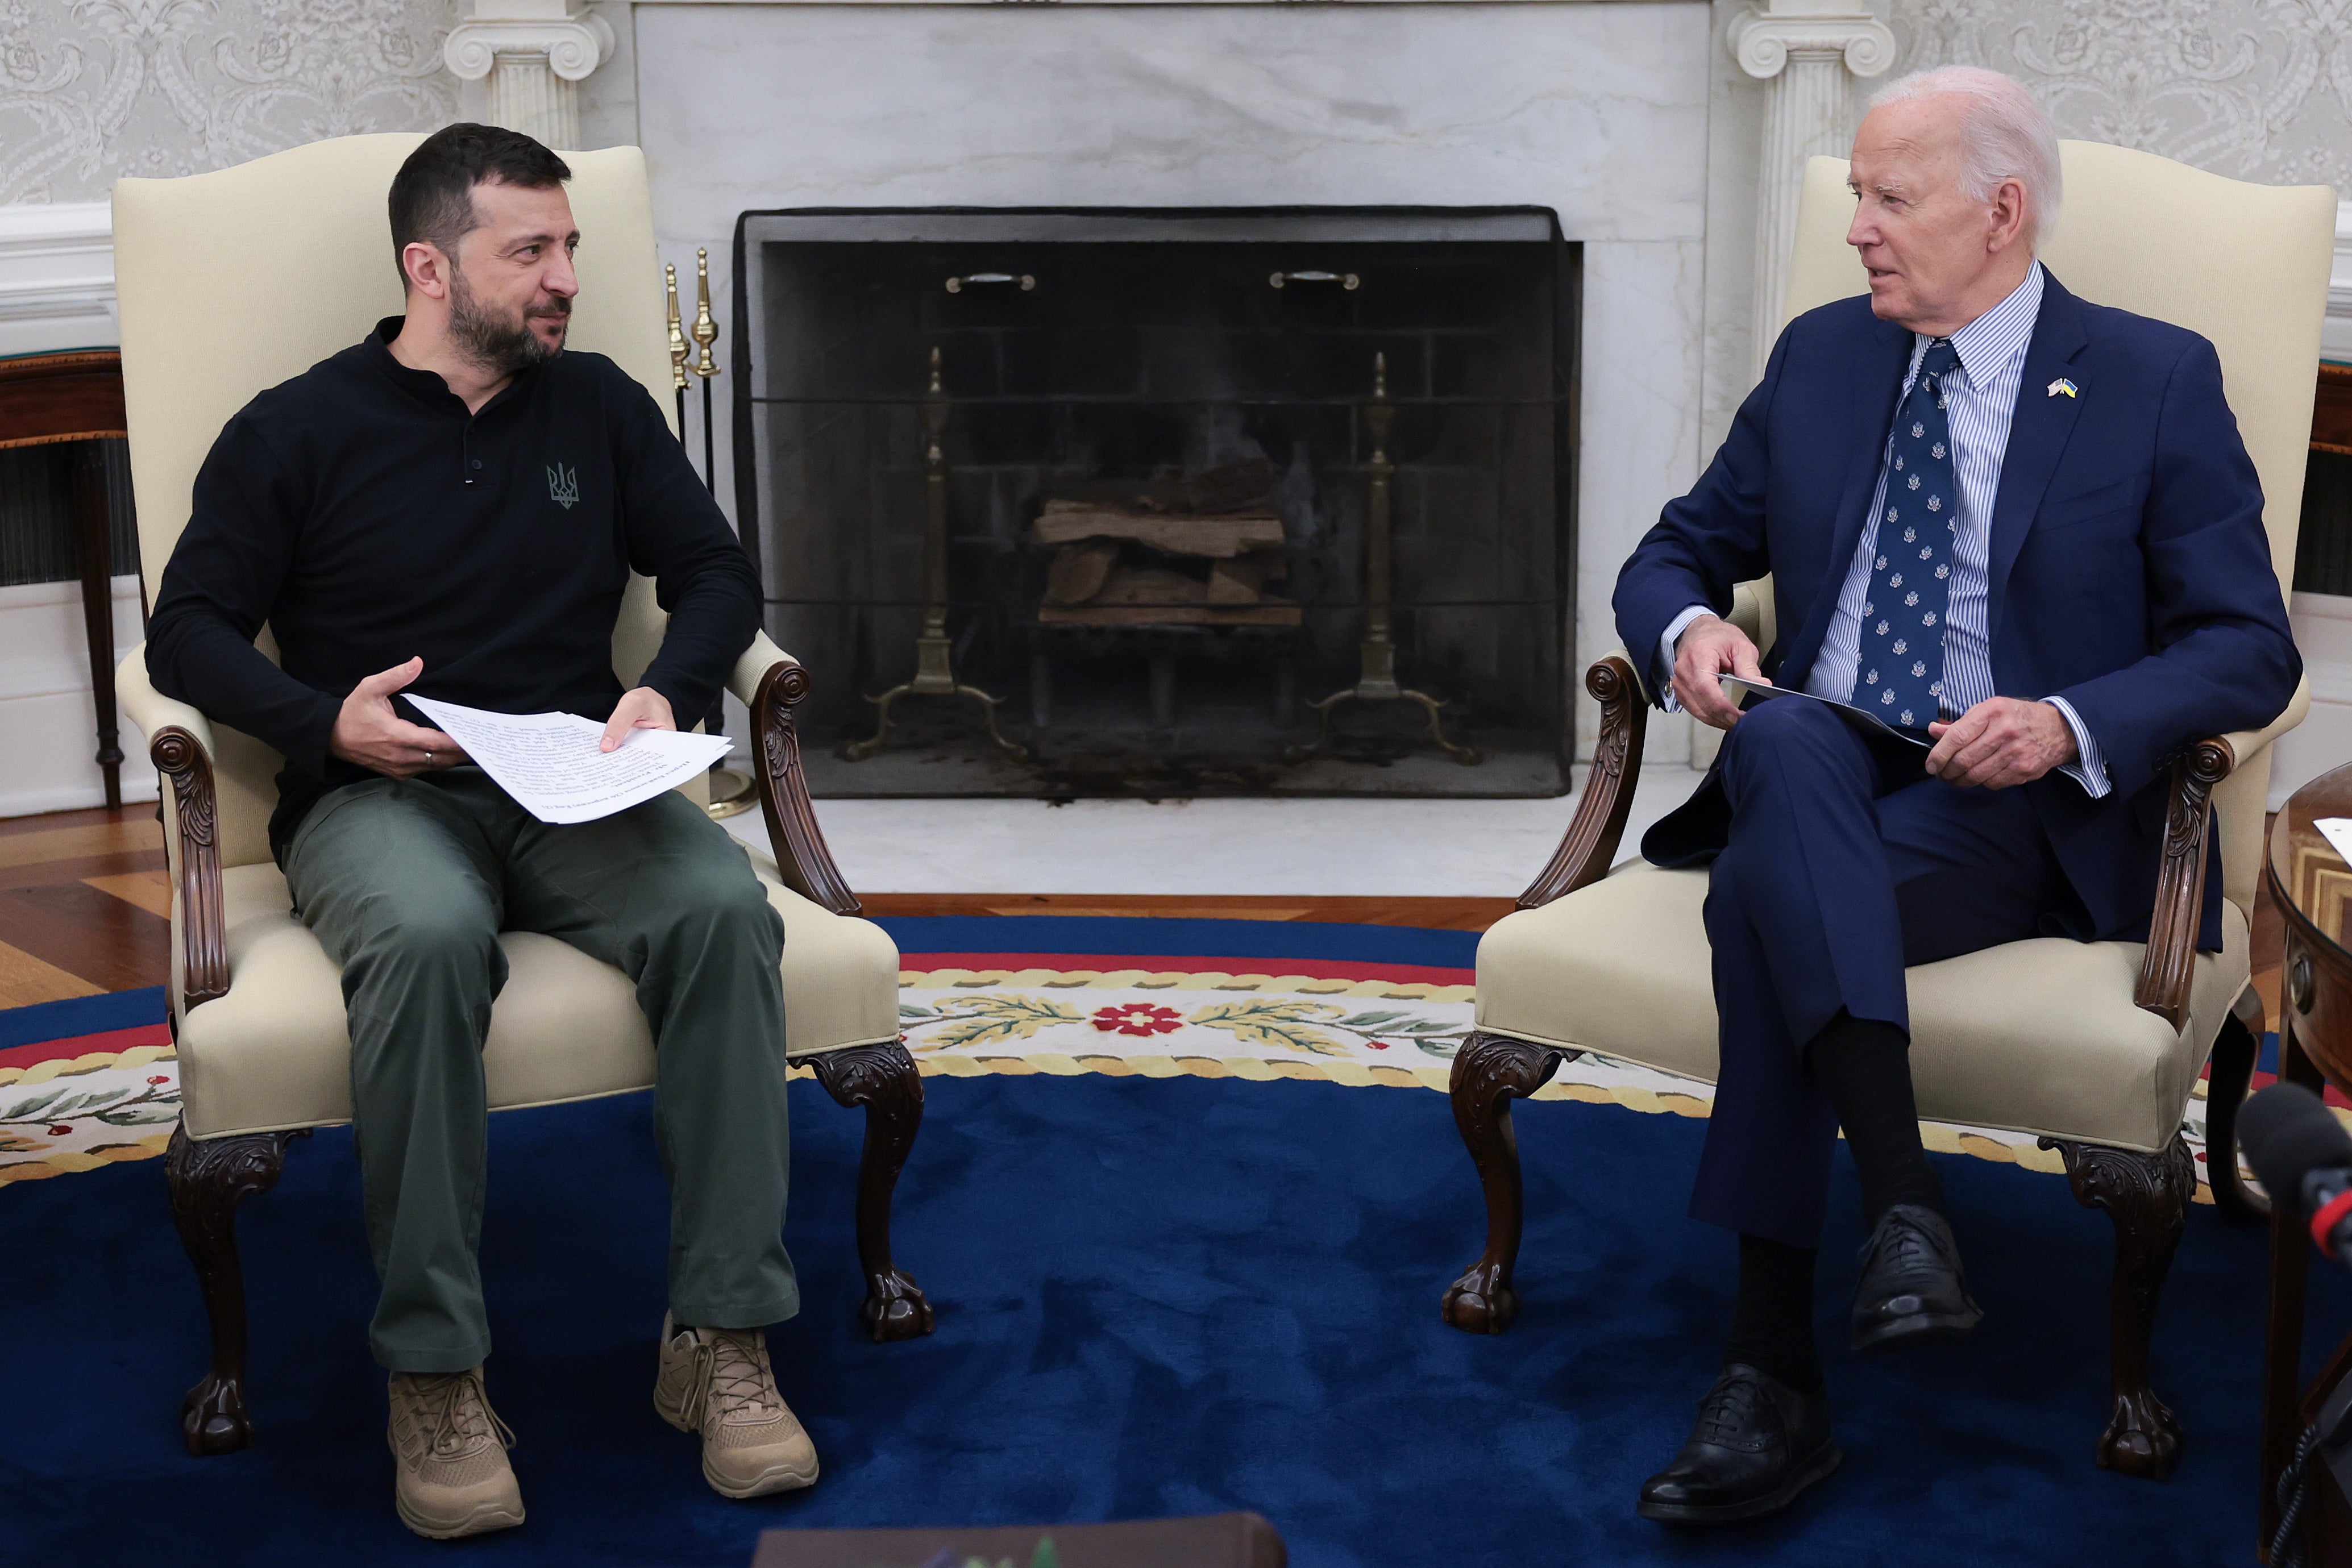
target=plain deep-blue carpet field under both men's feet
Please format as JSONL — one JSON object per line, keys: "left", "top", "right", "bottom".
{"left": 0, "top": 1076, "right": 2347, "bottom": 1568}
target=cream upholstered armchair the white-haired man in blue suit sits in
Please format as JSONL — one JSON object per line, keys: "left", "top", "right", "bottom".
{"left": 1444, "top": 141, "right": 2336, "bottom": 1479}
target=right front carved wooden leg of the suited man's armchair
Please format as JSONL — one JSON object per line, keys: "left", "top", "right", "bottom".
{"left": 2042, "top": 1133, "right": 2197, "bottom": 1481}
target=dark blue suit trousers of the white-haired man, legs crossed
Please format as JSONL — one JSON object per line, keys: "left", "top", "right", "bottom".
{"left": 1691, "top": 701, "right": 2072, "bottom": 1246}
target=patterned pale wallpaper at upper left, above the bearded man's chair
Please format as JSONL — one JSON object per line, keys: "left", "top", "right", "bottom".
{"left": 0, "top": 0, "right": 456, "bottom": 202}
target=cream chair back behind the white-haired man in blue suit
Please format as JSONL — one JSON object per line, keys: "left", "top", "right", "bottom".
{"left": 1778, "top": 141, "right": 2336, "bottom": 914}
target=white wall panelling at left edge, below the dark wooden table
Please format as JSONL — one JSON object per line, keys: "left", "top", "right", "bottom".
{"left": 0, "top": 576, "right": 155, "bottom": 816}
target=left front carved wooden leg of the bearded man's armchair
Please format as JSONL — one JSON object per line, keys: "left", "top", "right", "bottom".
{"left": 163, "top": 1126, "right": 296, "bottom": 1458}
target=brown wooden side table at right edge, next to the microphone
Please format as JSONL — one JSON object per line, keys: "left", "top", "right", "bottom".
{"left": 2248, "top": 766, "right": 2352, "bottom": 1568}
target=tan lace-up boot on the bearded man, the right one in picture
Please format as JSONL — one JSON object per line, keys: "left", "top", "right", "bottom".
{"left": 654, "top": 1314, "right": 816, "bottom": 1498}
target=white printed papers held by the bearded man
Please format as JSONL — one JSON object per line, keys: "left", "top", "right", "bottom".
{"left": 409, "top": 696, "right": 734, "bottom": 823}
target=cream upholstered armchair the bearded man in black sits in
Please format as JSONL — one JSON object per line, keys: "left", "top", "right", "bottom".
{"left": 115, "top": 134, "right": 932, "bottom": 1455}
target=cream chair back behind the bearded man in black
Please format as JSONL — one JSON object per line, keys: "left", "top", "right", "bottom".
{"left": 115, "top": 132, "right": 687, "bottom": 865}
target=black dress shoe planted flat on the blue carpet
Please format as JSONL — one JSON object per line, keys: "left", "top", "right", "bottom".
{"left": 1635, "top": 1361, "right": 1844, "bottom": 1523}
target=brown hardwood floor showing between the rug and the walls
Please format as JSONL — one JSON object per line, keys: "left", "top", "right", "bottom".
{"left": 0, "top": 806, "right": 2284, "bottom": 1028}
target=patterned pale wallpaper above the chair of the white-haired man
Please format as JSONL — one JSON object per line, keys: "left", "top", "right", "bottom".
{"left": 1889, "top": 0, "right": 2352, "bottom": 197}
